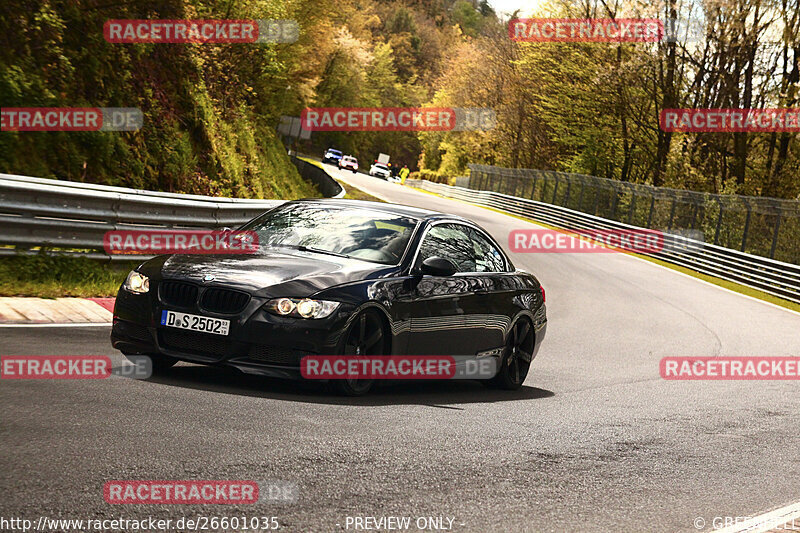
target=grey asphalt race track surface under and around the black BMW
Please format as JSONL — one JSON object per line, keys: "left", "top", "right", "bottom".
{"left": 0, "top": 167, "right": 800, "bottom": 532}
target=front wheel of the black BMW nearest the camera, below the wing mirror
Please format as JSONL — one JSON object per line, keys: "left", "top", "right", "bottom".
{"left": 333, "top": 309, "right": 388, "bottom": 396}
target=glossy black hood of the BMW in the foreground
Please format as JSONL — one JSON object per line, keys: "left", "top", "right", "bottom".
{"left": 139, "top": 250, "right": 398, "bottom": 298}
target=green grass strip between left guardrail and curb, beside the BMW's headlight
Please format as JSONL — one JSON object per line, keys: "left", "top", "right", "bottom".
{"left": 0, "top": 254, "right": 140, "bottom": 298}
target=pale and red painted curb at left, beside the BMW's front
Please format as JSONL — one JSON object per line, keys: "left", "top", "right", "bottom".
{"left": 0, "top": 297, "right": 114, "bottom": 327}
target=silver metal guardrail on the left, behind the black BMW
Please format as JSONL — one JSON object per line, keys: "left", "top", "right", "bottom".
{"left": 0, "top": 174, "right": 281, "bottom": 259}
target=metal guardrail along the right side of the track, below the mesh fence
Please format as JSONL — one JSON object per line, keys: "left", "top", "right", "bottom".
{"left": 406, "top": 180, "right": 800, "bottom": 303}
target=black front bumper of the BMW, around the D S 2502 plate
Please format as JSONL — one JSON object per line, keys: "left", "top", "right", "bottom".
{"left": 111, "top": 289, "right": 353, "bottom": 379}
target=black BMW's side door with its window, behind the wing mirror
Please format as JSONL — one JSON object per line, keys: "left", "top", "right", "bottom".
{"left": 407, "top": 222, "right": 476, "bottom": 355}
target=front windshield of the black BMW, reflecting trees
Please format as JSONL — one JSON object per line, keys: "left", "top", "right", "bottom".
{"left": 242, "top": 204, "right": 418, "bottom": 265}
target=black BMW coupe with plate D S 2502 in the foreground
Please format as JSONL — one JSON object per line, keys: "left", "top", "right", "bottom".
{"left": 111, "top": 200, "right": 547, "bottom": 395}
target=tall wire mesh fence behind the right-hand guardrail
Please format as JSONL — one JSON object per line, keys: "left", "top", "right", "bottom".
{"left": 466, "top": 164, "right": 800, "bottom": 265}
